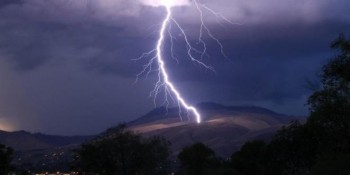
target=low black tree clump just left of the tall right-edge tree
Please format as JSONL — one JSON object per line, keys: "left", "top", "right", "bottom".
{"left": 231, "top": 121, "right": 316, "bottom": 175}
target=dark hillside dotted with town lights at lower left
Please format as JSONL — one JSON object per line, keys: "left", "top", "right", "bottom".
{"left": 0, "top": 131, "right": 93, "bottom": 172}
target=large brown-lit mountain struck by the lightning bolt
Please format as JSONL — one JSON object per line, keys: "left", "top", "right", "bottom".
{"left": 124, "top": 102, "right": 303, "bottom": 157}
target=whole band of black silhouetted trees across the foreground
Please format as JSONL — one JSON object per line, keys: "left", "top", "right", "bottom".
{"left": 0, "top": 35, "right": 350, "bottom": 175}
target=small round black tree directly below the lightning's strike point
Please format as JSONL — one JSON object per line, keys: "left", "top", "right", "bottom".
{"left": 178, "top": 142, "right": 215, "bottom": 175}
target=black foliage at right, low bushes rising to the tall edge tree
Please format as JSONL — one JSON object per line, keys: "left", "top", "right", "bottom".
{"left": 232, "top": 35, "right": 350, "bottom": 175}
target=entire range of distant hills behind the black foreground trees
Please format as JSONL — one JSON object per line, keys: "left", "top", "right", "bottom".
{"left": 0, "top": 102, "right": 304, "bottom": 171}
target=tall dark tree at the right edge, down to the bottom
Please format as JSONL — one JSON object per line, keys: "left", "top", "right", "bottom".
{"left": 306, "top": 34, "right": 350, "bottom": 174}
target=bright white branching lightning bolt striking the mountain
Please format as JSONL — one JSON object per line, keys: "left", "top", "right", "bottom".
{"left": 136, "top": 0, "right": 234, "bottom": 123}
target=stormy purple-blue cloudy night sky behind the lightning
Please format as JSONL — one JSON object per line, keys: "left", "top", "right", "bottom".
{"left": 0, "top": 0, "right": 350, "bottom": 135}
